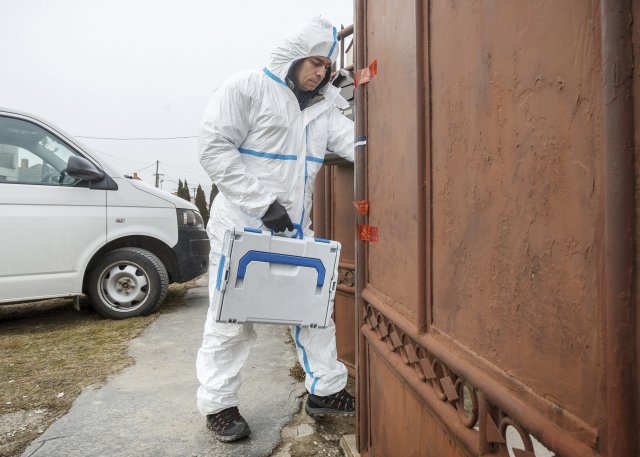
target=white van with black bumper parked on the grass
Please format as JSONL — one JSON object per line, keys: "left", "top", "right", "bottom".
{"left": 0, "top": 108, "right": 209, "bottom": 319}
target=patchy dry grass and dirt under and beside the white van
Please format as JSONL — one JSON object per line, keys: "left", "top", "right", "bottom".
{"left": 0, "top": 281, "right": 196, "bottom": 456}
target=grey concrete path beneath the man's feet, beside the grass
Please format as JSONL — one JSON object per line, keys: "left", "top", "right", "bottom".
{"left": 23, "top": 287, "right": 300, "bottom": 457}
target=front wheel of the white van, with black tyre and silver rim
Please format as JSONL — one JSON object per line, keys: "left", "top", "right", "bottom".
{"left": 88, "top": 248, "right": 169, "bottom": 319}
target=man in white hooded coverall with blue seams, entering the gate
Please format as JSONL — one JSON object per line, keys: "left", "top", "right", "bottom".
{"left": 196, "top": 18, "right": 355, "bottom": 441}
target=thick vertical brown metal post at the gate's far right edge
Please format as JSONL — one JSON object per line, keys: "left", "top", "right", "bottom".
{"left": 599, "top": 0, "right": 640, "bottom": 457}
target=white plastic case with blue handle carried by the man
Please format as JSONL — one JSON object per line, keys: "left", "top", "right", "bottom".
{"left": 214, "top": 229, "right": 340, "bottom": 328}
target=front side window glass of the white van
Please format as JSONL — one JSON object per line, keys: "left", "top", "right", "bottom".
{"left": 0, "top": 116, "right": 80, "bottom": 186}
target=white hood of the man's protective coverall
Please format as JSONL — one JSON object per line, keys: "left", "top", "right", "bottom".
{"left": 267, "top": 18, "right": 338, "bottom": 87}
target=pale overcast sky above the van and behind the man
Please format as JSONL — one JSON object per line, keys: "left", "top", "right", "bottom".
{"left": 0, "top": 0, "right": 353, "bottom": 199}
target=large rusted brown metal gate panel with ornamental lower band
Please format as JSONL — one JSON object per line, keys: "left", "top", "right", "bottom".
{"left": 350, "top": 0, "right": 640, "bottom": 457}
